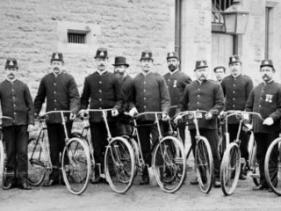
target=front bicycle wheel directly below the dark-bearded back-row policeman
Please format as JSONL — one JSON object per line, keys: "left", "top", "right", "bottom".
{"left": 152, "top": 136, "right": 186, "bottom": 193}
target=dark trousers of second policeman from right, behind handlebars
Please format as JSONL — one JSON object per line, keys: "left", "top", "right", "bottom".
{"left": 228, "top": 124, "right": 250, "bottom": 161}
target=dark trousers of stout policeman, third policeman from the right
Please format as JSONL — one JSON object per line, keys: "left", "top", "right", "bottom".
{"left": 190, "top": 129, "right": 220, "bottom": 178}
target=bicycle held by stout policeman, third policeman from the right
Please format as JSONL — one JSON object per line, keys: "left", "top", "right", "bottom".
{"left": 176, "top": 110, "right": 214, "bottom": 194}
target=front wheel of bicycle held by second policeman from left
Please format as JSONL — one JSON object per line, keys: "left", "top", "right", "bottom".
{"left": 62, "top": 137, "right": 91, "bottom": 195}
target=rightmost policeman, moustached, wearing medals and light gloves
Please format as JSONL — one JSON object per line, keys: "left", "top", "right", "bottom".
{"left": 246, "top": 59, "right": 281, "bottom": 190}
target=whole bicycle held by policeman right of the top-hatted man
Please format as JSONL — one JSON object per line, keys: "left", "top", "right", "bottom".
{"left": 129, "top": 111, "right": 186, "bottom": 193}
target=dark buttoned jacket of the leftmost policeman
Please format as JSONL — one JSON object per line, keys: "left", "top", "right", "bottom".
{"left": 0, "top": 80, "right": 34, "bottom": 127}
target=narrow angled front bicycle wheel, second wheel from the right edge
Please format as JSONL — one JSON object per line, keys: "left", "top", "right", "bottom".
{"left": 220, "top": 143, "right": 241, "bottom": 196}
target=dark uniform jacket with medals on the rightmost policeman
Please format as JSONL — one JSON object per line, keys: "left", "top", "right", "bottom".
{"left": 246, "top": 81, "right": 281, "bottom": 133}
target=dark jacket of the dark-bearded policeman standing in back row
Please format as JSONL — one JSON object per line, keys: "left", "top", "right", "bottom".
{"left": 164, "top": 70, "right": 191, "bottom": 117}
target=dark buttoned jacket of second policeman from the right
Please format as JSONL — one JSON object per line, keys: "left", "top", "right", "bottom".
{"left": 221, "top": 75, "right": 253, "bottom": 124}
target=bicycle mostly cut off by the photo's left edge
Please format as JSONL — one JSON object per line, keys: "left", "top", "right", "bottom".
{"left": 0, "top": 116, "right": 13, "bottom": 187}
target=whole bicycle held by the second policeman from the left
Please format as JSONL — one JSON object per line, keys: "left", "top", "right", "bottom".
{"left": 28, "top": 111, "right": 90, "bottom": 194}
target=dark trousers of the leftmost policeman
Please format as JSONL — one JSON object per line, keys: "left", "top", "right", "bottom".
{"left": 3, "top": 125, "right": 28, "bottom": 179}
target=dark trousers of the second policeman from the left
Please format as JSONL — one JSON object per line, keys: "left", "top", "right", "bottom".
{"left": 47, "top": 121, "right": 72, "bottom": 179}
